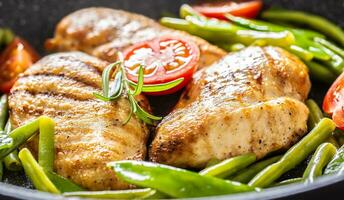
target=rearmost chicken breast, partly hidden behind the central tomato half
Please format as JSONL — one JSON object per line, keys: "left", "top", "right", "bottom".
{"left": 46, "top": 8, "right": 225, "bottom": 67}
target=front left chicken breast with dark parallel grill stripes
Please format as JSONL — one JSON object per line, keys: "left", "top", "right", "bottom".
{"left": 9, "top": 52, "right": 148, "bottom": 190}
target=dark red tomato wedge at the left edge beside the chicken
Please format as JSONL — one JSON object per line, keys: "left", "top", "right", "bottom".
{"left": 0, "top": 38, "right": 39, "bottom": 93}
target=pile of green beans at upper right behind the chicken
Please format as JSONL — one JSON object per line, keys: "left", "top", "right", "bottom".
{"left": 160, "top": 5, "right": 344, "bottom": 84}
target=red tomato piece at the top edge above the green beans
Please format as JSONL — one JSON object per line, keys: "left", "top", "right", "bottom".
{"left": 193, "top": 0, "right": 263, "bottom": 19}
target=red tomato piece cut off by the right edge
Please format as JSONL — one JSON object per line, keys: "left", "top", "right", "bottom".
{"left": 323, "top": 72, "right": 344, "bottom": 130}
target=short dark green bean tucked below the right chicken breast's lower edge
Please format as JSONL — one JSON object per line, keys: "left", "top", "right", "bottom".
{"left": 229, "top": 156, "right": 282, "bottom": 183}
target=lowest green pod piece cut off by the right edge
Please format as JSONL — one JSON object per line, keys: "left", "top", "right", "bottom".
{"left": 324, "top": 145, "right": 344, "bottom": 176}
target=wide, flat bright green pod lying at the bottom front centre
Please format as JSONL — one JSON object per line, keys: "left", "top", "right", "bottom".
{"left": 108, "top": 161, "right": 255, "bottom": 198}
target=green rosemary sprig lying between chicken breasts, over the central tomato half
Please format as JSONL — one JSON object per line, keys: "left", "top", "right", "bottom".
{"left": 94, "top": 53, "right": 184, "bottom": 125}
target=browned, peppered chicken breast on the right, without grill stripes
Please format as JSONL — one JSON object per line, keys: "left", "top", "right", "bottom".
{"left": 150, "top": 47, "right": 310, "bottom": 168}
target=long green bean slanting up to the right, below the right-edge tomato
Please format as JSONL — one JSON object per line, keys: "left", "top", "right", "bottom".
{"left": 249, "top": 118, "right": 336, "bottom": 187}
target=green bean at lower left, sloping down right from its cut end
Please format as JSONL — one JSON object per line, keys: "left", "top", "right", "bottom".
{"left": 19, "top": 148, "right": 60, "bottom": 194}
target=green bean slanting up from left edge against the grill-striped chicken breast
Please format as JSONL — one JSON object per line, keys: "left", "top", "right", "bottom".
{"left": 0, "top": 117, "right": 41, "bottom": 160}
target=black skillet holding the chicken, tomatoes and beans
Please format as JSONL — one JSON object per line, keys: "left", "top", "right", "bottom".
{"left": 0, "top": 0, "right": 344, "bottom": 200}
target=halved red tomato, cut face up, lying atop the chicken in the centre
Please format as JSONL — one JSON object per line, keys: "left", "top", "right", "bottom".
{"left": 124, "top": 36, "right": 200, "bottom": 95}
